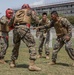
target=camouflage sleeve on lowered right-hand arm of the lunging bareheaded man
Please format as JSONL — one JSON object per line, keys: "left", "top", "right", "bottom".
{"left": 62, "top": 18, "right": 72, "bottom": 37}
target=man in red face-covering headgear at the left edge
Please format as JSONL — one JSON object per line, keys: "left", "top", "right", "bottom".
{"left": 0, "top": 8, "right": 13, "bottom": 64}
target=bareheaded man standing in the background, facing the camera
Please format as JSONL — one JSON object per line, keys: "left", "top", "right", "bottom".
{"left": 37, "top": 12, "right": 50, "bottom": 59}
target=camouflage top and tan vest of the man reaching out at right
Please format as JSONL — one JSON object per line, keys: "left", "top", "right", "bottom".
{"left": 42, "top": 17, "right": 72, "bottom": 37}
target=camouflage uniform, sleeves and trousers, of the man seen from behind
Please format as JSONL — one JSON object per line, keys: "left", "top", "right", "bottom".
{"left": 9, "top": 9, "right": 38, "bottom": 60}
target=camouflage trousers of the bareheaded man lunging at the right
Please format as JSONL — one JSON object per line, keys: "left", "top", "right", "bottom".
{"left": 52, "top": 37, "right": 74, "bottom": 62}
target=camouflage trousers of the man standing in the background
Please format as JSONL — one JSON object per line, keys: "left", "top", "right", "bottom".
{"left": 38, "top": 31, "right": 50, "bottom": 55}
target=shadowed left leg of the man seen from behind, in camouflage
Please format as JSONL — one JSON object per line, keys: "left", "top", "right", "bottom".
{"left": 11, "top": 29, "right": 21, "bottom": 60}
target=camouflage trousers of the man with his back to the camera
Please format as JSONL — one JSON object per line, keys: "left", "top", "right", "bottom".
{"left": 11, "top": 26, "right": 36, "bottom": 60}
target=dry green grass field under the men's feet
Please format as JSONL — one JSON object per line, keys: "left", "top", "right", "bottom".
{"left": 0, "top": 38, "right": 74, "bottom": 75}
